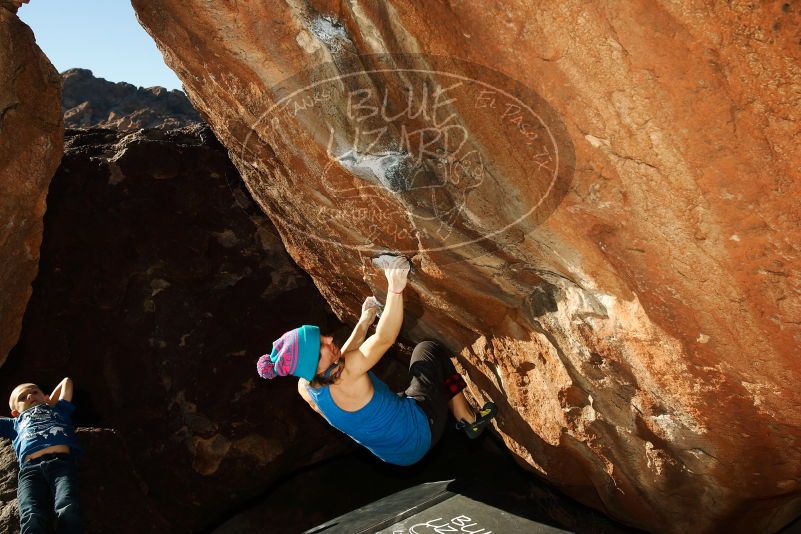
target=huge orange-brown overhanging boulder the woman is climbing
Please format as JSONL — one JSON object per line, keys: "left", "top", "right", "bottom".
{"left": 133, "top": 0, "right": 801, "bottom": 532}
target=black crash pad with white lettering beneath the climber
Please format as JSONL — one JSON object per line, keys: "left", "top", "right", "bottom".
{"left": 304, "top": 480, "right": 567, "bottom": 534}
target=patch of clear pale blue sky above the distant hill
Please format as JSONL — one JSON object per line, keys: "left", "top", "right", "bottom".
{"left": 18, "top": 0, "right": 181, "bottom": 89}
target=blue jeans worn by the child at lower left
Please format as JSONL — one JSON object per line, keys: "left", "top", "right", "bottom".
{"left": 17, "top": 454, "right": 82, "bottom": 534}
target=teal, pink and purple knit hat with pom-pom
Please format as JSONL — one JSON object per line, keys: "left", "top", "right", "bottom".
{"left": 256, "top": 324, "right": 320, "bottom": 381}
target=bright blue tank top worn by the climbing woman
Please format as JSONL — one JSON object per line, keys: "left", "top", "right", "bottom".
{"left": 306, "top": 371, "right": 431, "bottom": 465}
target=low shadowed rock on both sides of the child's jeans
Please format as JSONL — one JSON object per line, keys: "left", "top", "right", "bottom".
{"left": 0, "top": 428, "right": 170, "bottom": 534}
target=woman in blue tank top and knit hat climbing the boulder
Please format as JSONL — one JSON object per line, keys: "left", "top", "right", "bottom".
{"left": 257, "top": 255, "right": 496, "bottom": 465}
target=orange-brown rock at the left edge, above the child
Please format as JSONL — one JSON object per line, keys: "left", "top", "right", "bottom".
{"left": 0, "top": 1, "right": 64, "bottom": 365}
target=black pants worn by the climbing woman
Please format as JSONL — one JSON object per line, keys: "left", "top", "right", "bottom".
{"left": 404, "top": 340, "right": 465, "bottom": 447}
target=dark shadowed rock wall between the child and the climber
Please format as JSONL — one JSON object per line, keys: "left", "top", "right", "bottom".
{"left": 0, "top": 127, "right": 352, "bottom": 532}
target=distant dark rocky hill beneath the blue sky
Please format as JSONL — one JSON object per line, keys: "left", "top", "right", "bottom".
{"left": 61, "top": 69, "right": 201, "bottom": 131}
